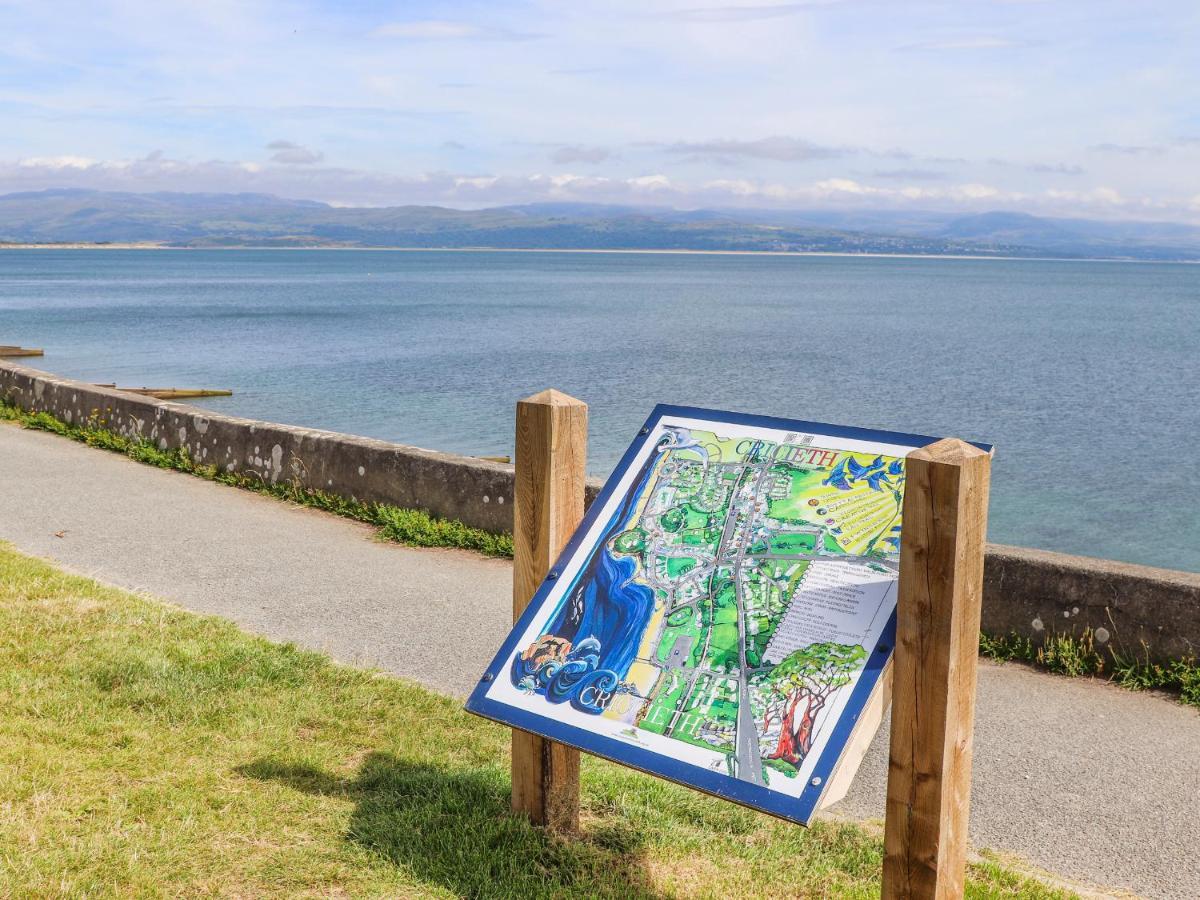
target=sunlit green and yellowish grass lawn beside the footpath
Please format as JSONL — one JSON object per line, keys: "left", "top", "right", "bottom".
{"left": 0, "top": 544, "right": 1067, "bottom": 899}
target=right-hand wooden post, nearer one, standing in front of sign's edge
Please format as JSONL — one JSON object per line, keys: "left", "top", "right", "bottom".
{"left": 883, "top": 439, "right": 991, "bottom": 900}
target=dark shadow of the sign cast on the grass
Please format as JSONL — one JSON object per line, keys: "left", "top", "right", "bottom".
{"left": 236, "top": 752, "right": 664, "bottom": 899}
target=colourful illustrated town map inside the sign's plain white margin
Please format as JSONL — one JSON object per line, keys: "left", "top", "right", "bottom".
{"left": 509, "top": 424, "right": 904, "bottom": 787}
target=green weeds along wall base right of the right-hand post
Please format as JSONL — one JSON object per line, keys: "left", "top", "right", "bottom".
{"left": 979, "top": 631, "right": 1200, "bottom": 707}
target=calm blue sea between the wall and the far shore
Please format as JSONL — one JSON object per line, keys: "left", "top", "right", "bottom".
{"left": 0, "top": 250, "right": 1200, "bottom": 571}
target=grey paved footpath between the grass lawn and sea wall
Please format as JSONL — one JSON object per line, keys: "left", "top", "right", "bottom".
{"left": 0, "top": 422, "right": 1200, "bottom": 898}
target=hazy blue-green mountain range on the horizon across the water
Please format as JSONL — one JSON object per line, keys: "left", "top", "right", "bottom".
{"left": 0, "top": 190, "right": 1200, "bottom": 260}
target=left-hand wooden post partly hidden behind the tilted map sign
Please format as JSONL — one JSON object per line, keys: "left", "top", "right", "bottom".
{"left": 512, "top": 390, "right": 588, "bottom": 833}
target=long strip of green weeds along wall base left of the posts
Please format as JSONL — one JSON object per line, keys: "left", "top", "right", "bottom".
{"left": 0, "top": 400, "right": 512, "bottom": 559}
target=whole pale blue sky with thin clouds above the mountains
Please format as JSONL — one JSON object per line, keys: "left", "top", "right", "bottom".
{"left": 0, "top": 0, "right": 1200, "bottom": 222}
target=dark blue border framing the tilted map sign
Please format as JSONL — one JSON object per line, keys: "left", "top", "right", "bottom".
{"left": 466, "top": 403, "right": 991, "bottom": 826}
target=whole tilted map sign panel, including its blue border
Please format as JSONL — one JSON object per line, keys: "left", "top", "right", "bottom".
{"left": 468, "top": 407, "right": 932, "bottom": 823}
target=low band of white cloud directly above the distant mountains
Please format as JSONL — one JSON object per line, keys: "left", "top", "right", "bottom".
{"left": 0, "top": 151, "right": 1200, "bottom": 218}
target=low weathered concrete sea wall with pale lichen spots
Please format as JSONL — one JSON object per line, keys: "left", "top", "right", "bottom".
{"left": 0, "top": 360, "right": 1200, "bottom": 661}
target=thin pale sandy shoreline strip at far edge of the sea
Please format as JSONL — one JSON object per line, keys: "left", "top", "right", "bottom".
{"left": 0, "top": 241, "right": 1200, "bottom": 265}
